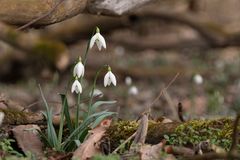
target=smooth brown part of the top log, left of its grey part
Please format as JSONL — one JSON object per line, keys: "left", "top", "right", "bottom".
{"left": 0, "top": 0, "right": 87, "bottom": 25}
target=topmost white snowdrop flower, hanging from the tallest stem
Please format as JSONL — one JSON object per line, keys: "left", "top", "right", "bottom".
{"left": 89, "top": 27, "right": 106, "bottom": 51}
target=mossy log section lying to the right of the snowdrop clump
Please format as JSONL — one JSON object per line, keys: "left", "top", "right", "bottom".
{"left": 103, "top": 118, "right": 235, "bottom": 151}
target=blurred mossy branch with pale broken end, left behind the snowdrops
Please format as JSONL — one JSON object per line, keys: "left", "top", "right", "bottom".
{"left": 0, "top": 22, "right": 69, "bottom": 70}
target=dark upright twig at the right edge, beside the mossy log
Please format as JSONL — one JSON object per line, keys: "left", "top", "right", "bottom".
{"left": 229, "top": 113, "right": 240, "bottom": 153}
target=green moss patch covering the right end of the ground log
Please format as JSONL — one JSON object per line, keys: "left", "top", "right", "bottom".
{"left": 165, "top": 118, "right": 236, "bottom": 149}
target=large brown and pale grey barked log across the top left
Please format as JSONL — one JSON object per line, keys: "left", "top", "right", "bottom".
{"left": 0, "top": 0, "right": 152, "bottom": 26}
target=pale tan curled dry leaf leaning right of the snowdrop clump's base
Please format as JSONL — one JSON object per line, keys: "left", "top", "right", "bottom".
{"left": 73, "top": 119, "right": 111, "bottom": 160}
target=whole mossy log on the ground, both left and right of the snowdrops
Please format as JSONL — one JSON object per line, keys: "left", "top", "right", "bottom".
{"left": 0, "top": 109, "right": 236, "bottom": 151}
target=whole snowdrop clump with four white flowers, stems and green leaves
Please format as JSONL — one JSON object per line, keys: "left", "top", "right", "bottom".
{"left": 39, "top": 27, "right": 117, "bottom": 152}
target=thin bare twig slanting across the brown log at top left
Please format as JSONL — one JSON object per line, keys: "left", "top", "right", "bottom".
{"left": 16, "top": 0, "right": 64, "bottom": 31}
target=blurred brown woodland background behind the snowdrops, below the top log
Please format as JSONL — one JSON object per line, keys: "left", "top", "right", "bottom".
{"left": 0, "top": 0, "right": 240, "bottom": 119}
